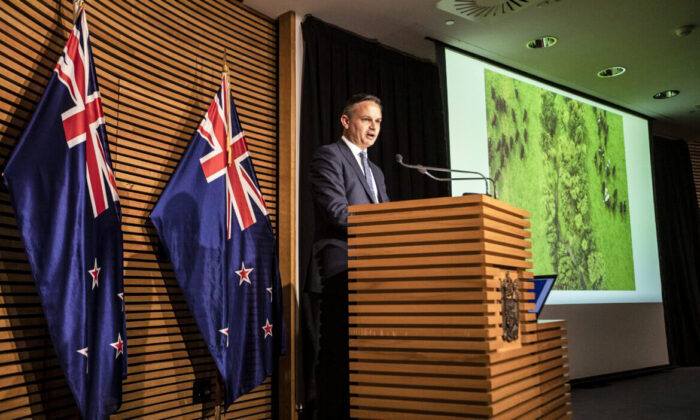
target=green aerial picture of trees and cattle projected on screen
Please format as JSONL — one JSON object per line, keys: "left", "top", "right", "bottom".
{"left": 484, "top": 69, "right": 635, "bottom": 290}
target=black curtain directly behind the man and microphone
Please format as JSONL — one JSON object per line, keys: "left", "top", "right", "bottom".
{"left": 299, "top": 16, "right": 450, "bottom": 284}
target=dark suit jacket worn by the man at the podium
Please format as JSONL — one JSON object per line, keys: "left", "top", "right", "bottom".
{"left": 304, "top": 139, "right": 389, "bottom": 293}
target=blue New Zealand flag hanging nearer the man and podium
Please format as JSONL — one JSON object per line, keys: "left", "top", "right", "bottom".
{"left": 151, "top": 73, "right": 285, "bottom": 407}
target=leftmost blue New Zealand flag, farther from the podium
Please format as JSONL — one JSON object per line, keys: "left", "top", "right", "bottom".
{"left": 4, "top": 10, "right": 127, "bottom": 419}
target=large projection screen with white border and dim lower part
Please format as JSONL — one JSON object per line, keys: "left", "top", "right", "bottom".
{"left": 438, "top": 45, "right": 668, "bottom": 377}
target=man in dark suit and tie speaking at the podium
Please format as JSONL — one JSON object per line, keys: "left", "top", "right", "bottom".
{"left": 302, "top": 94, "right": 389, "bottom": 419}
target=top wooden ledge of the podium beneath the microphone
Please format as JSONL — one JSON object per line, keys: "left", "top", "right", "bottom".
{"left": 348, "top": 194, "right": 530, "bottom": 219}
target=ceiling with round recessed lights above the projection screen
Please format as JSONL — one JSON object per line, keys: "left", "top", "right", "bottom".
{"left": 244, "top": 0, "right": 700, "bottom": 133}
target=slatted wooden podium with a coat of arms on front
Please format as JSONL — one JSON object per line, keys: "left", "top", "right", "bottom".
{"left": 348, "top": 195, "right": 571, "bottom": 419}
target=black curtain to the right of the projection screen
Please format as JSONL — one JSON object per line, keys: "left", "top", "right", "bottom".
{"left": 652, "top": 138, "right": 700, "bottom": 366}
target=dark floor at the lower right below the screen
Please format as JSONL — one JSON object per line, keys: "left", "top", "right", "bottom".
{"left": 571, "top": 367, "right": 700, "bottom": 420}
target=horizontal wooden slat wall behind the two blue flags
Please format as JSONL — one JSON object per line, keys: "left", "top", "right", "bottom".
{"left": 0, "top": 0, "right": 278, "bottom": 418}
